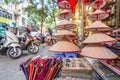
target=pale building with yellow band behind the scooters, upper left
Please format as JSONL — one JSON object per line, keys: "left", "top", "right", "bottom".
{"left": 0, "top": 0, "right": 27, "bottom": 27}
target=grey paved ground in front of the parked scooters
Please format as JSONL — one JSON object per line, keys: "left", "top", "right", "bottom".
{"left": 0, "top": 47, "right": 52, "bottom": 80}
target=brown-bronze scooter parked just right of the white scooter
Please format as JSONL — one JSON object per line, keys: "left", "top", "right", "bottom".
{"left": 17, "top": 28, "right": 40, "bottom": 54}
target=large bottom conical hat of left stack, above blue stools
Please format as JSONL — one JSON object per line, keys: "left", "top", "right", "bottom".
{"left": 49, "top": 39, "right": 80, "bottom": 52}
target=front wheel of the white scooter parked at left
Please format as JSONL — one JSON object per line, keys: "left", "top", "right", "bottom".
{"left": 6, "top": 47, "right": 22, "bottom": 59}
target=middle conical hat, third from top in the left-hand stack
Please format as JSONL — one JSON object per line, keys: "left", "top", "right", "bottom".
{"left": 56, "top": 20, "right": 76, "bottom": 30}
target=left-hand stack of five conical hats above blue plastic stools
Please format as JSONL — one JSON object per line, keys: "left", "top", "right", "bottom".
{"left": 49, "top": 0, "right": 80, "bottom": 53}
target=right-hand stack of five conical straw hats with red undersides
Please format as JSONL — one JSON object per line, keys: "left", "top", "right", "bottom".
{"left": 80, "top": 0, "right": 118, "bottom": 60}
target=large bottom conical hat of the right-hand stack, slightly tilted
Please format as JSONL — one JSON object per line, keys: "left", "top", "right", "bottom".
{"left": 80, "top": 44, "right": 117, "bottom": 59}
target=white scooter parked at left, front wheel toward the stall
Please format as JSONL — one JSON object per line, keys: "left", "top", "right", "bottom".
{"left": 0, "top": 30, "right": 22, "bottom": 58}
